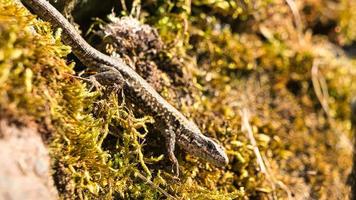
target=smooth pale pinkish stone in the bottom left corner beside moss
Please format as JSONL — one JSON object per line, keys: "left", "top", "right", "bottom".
{"left": 0, "top": 119, "right": 58, "bottom": 200}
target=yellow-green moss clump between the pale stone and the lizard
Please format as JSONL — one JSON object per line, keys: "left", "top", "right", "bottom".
{"left": 0, "top": 0, "right": 161, "bottom": 199}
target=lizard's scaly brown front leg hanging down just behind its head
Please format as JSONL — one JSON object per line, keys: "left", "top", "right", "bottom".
{"left": 165, "top": 128, "right": 179, "bottom": 179}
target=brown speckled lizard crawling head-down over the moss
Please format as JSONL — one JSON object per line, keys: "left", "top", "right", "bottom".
{"left": 21, "top": 0, "right": 229, "bottom": 177}
